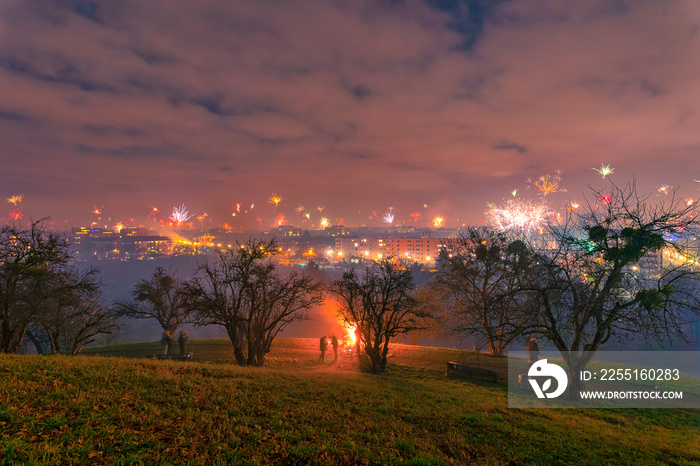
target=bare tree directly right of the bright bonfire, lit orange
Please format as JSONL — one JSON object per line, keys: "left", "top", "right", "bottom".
{"left": 329, "top": 258, "right": 428, "bottom": 373}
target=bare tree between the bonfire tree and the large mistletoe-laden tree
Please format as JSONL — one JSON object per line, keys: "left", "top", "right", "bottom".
{"left": 433, "top": 228, "right": 533, "bottom": 356}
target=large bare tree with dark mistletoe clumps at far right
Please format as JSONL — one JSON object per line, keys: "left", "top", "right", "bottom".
{"left": 528, "top": 181, "right": 700, "bottom": 398}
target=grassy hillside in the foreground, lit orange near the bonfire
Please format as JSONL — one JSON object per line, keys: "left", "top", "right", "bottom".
{"left": 0, "top": 339, "right": 700, "bottom": 465}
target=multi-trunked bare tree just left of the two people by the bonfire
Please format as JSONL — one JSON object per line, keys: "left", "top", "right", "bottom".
{"left": 185, "top": 239, "right": 322, "bottom": 366}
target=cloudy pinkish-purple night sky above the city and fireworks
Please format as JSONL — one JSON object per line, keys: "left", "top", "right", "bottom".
{"left": 0, "top": 0, "right": 700, "bottom": 227}
